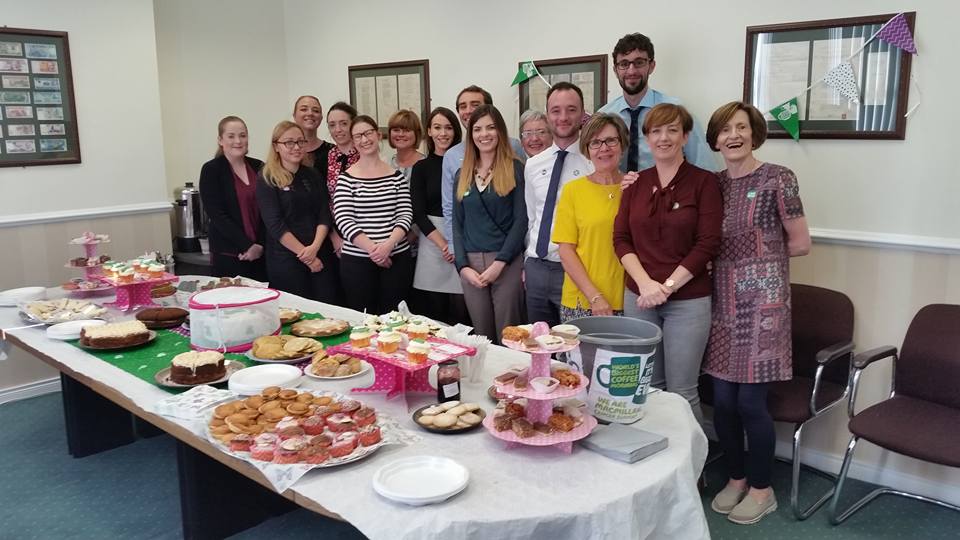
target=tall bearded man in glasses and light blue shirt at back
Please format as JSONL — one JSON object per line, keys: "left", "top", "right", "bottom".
{"left": 599, "top": 33, "right": 717, "bottom": 172}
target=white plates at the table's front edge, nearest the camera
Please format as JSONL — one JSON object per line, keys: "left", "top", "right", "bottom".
{"left": 373, "top": 456, "right": 470, "bottom": 506}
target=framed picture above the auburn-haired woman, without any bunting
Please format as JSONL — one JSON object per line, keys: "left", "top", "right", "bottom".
{"left": 347, "top": 60, "right": 430, "bottom": 134}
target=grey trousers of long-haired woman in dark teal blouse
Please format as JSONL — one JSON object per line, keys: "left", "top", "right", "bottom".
{"left": 460, "top": 253, "right": 526, "bottom": 344}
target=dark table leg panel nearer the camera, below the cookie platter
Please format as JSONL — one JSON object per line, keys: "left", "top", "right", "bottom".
{"left": 177, "top": 441, "right": 297, "bottom": 540}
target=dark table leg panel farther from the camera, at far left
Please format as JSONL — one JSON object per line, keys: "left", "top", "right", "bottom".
{"left": 60, "top": 373, "right": 136, "bottom": 458}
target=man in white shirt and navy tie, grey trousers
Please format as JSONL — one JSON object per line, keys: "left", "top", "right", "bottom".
{"left": 524, "top": 82, "right": 593, "bottom": 326}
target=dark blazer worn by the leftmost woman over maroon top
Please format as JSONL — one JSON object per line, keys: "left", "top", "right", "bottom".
{"left": 200, "top": 156, "right": 265, "bottom": 255}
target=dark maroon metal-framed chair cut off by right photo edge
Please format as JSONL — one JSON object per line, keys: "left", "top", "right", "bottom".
{"left": 830, "top": 304, "right": 960, "bottom": 525}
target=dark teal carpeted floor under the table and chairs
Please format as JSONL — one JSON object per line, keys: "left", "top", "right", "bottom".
{"left": 0, "top": 394, "right": 960, "bottom": 540}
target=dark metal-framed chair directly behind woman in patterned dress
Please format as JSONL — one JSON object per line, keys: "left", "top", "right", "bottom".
{"left": 699, "top": 284, "right": 854, "bottom": 520}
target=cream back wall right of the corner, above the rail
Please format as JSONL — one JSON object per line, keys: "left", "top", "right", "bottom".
{"left": 285, "top": 0, "right": 960, "bottom": 243}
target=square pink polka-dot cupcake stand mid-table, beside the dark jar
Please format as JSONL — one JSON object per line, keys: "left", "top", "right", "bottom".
{"left": 327, "top": 337, "right": 477, "bottom": 399}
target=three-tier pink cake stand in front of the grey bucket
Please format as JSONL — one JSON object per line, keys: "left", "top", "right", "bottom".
{"left": 483, "top": 322, "right": 597, "bottom": 453}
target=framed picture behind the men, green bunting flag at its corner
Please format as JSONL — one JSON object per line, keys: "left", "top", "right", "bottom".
{"left": 517, "top": 54, "right": 607, "bottom": 122}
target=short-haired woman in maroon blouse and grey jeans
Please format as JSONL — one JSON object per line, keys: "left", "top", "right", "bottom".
{"left": 613, "top": 103, "right": 723, "bottom": 421}
